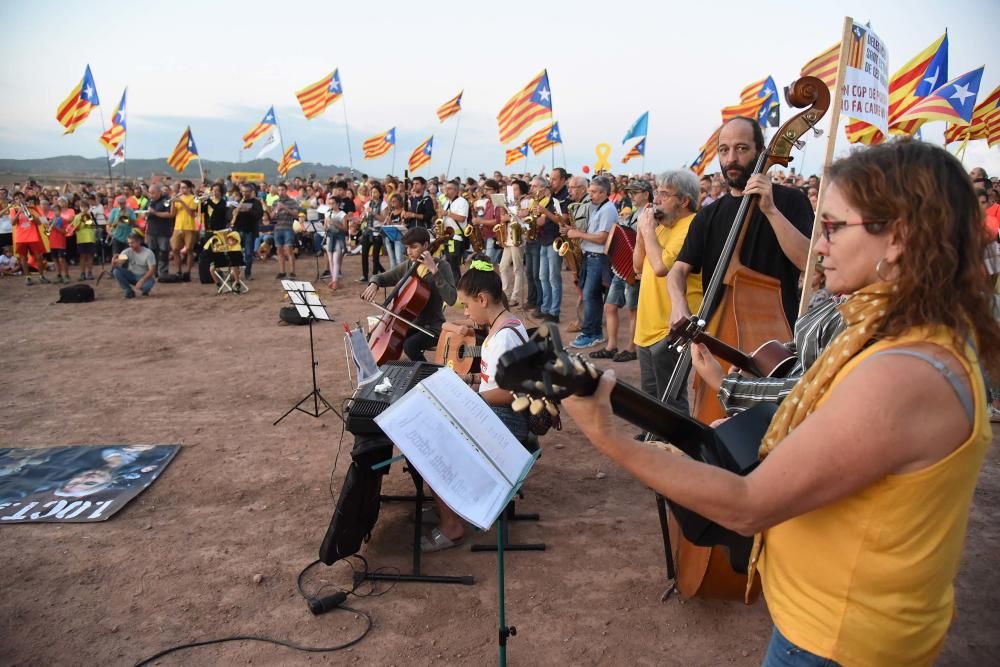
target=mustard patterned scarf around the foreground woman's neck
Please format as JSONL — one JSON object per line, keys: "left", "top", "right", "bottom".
{"left": 747, "top": 282, "right": 895, "bottom": 604}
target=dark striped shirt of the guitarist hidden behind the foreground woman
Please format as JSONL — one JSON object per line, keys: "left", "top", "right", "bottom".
{"left": 719, "top": 296, "right": 847, "bottom": 416}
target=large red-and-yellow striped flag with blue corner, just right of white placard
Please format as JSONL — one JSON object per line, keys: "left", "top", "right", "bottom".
{"left": 845, "top": 32, "right": 948, "bottom": 145}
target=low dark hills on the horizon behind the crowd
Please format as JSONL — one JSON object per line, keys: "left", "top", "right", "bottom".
{"left": 0, "top": 155, "right": 360, "bottom": 183}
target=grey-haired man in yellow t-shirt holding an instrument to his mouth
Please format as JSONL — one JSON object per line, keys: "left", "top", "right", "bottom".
{"left": 632, "top": 169, "right": 702, "bottom": 412}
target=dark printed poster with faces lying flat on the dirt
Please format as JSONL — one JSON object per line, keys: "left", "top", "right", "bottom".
{"left": 0, "top": 445, "right": 180, "bottom": 526}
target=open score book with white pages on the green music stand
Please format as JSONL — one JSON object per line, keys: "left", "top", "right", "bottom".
{"left": 375, "top": 368, "right": 538, "bottom": 530}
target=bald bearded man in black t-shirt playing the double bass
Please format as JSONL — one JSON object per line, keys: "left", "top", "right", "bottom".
{"left": 667, "top": 116, "right": 813, "bottom": 328}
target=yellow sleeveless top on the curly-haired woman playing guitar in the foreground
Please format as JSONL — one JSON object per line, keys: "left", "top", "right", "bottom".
{"left": 758, "top": 329, "right": 993, "bottom": 666}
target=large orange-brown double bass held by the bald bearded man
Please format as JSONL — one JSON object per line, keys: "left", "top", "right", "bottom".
{"left": 657, "top": 76, "right": 830, "bottom": 604}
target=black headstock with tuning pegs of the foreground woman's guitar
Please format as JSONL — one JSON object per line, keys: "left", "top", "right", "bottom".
{"left": 494, "top": 324, "right": 601, "bottom": 402}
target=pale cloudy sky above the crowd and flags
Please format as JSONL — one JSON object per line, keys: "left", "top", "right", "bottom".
{"left": 0, "top": 0, "right": 1000, "bottom": 176}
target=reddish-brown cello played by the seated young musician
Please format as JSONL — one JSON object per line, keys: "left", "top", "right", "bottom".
{"left": 368, "top": 236, "right": 449, "bottom": 366}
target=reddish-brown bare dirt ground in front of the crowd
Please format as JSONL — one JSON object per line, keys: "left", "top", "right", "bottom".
{"left": 0, "top": 252, "right": 1000, "bottom": 665}
